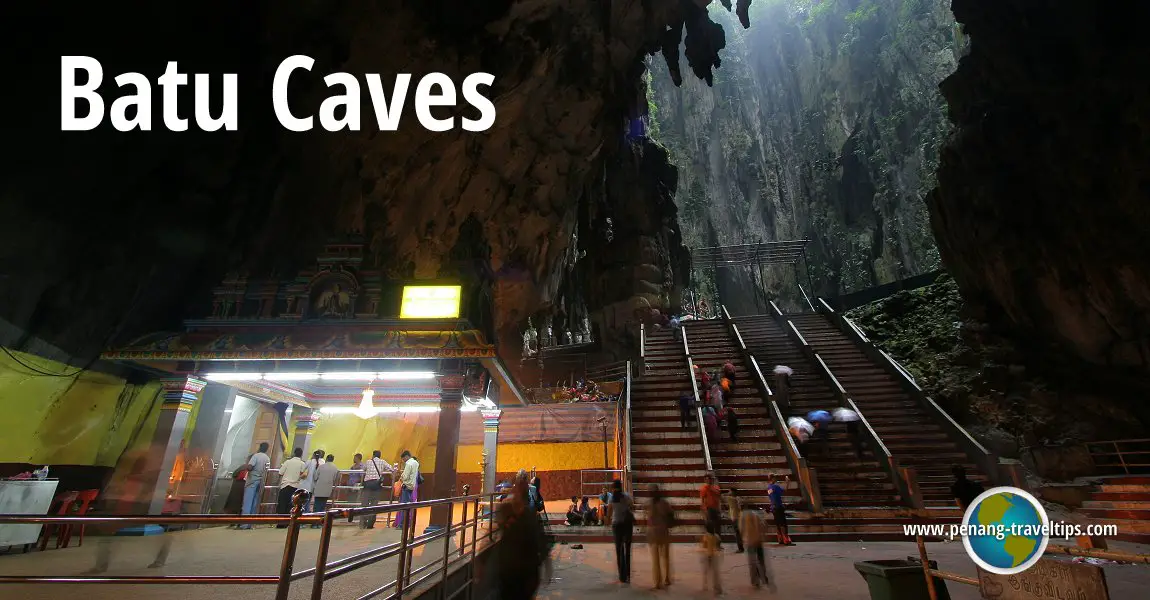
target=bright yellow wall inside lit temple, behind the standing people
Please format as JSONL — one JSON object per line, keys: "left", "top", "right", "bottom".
{"left": 308, "top": 414, "right": 439, "bottom": 472}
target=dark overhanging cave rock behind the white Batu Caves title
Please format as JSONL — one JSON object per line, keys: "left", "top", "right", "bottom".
{"left": 0, "top": 0, "right": 736, "bottom": 362}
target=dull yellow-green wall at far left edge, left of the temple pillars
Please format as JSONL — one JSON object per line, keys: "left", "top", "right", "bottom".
{"left": 0, "top": 351, "right": 163, "bottom": 467}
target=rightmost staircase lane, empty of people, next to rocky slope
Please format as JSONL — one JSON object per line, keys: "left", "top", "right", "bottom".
{"left": 787, "top": 314, "right": 987, "bottom": 509}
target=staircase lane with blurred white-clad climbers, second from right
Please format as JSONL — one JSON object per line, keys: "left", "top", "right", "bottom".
{"left": 735, "top": 315, "right": 904, "bottom": 508}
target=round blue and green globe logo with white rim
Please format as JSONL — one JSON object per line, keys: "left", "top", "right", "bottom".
{"left": 963, "top": 487, "right": 1050, "bottom": 575}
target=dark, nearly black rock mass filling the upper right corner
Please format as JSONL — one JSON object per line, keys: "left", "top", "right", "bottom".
{"left": 929, "top": 0, "right": 1150, "bottom": 372}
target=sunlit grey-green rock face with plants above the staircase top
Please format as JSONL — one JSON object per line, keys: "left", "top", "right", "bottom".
{"left": 651, "top": 0, "right": 963, "bottom": 311}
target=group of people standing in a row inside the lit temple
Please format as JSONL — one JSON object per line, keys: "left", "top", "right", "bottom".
{"left": 228, "top": 443, "right": 423, "bottom": 529}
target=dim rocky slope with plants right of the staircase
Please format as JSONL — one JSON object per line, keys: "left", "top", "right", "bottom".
{"left": 848, "top": 276, "right": 1145, "bottom": 445}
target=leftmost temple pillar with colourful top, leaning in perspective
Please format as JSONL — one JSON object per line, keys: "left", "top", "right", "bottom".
{"left": 143, "top": 377, "right": 207, "bottom": 515}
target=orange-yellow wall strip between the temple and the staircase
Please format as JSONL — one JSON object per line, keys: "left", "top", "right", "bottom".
{"left": 455, "top": 441, "right": 615, "bottom": 472}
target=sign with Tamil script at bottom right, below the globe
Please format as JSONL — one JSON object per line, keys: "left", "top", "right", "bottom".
{"left": 979, "top": 559, "right": 1110, "bottom": 600}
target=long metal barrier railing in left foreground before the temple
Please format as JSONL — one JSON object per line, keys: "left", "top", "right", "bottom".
{"left": 0, "top": 485, "right": 495, "bottom": 600}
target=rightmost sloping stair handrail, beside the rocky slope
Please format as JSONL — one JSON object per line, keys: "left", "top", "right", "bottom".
{"left": 819, "top": 299, "right": 1007, "bottom": 486}
